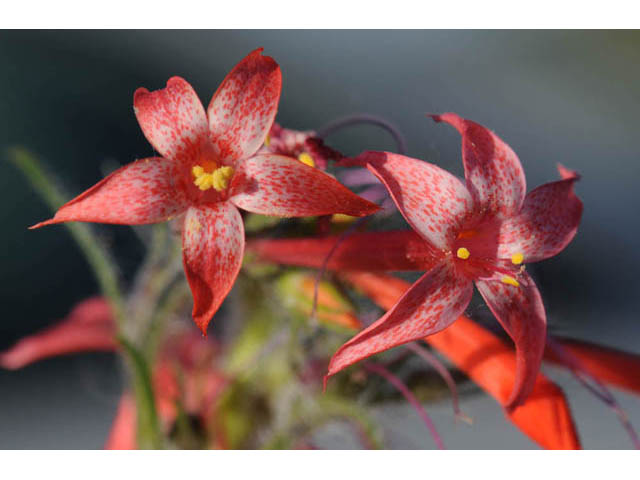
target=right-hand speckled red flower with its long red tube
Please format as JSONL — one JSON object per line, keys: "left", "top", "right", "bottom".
{"left": 253, "top": 113, "right": 582, "bottom": 408}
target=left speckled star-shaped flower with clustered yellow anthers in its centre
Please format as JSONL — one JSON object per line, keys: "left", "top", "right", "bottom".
{"left": 31, "top": 49, "right": 378, "bottom": 333}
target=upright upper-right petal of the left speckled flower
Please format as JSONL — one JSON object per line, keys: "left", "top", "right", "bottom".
{"left": 208, "top": 48, "right": 282, "bottom": 160}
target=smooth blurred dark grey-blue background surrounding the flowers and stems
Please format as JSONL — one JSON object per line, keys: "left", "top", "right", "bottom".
{"left": 0, "top": 30, "right": 640, "bottom": 448}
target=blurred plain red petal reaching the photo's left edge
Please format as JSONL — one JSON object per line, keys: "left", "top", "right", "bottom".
{"left": 0, "top": 297, "right": 116, "bottom": 370}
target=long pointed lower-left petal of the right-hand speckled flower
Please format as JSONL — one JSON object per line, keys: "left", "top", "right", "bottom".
{"left": 325, "top": 261, "right": 473, "bottom": 381}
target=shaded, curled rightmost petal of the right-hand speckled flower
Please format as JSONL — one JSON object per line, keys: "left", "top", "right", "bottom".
{"left": 498, "top": 167, "right": 582, "bottom": 263}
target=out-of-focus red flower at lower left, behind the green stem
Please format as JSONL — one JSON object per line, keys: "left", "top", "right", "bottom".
{"left": 0, "top": 297, "right": 226, "bottom": 449}
